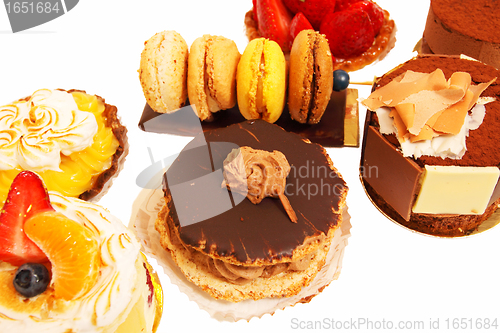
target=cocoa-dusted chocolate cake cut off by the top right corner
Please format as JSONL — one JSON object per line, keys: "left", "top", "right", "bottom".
{"left": 424, "top": 0, "right": 500, "bottom": 68}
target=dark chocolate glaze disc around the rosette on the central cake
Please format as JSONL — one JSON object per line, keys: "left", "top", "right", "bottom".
{"left": 163, "top": 120, "right": 347, "bottom": 263}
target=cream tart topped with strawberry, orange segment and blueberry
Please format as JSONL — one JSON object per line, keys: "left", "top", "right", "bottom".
{"left": 0, "top": 171, "right": 162, "bottom": 333}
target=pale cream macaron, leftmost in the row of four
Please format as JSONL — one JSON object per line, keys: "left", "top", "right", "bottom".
{"left": 139, "top": 30, "right": 189, "bottom": 113}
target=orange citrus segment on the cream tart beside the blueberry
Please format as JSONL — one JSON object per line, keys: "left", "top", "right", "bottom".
{"left": 24, "top": 211, "right": 100, "bottom": 300}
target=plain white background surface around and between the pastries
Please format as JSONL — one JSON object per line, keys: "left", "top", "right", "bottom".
{"left": 0, "top": 0, "right": 500, "bottom": 332}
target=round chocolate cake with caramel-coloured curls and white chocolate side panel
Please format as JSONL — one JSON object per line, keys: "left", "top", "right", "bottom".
{"left": 360, "top": 55, "right": 500, "bottom": 236}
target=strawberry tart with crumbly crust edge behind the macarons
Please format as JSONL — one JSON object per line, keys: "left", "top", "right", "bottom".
{"left": 245, "top": 0, "right": 396, "bottom": 71}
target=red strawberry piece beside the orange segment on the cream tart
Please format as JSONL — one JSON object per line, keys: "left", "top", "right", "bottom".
{"left": 0, "top": 171, "right": 53, "bottom": 266}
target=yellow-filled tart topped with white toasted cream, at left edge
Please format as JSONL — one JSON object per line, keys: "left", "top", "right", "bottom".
{"left": 0, "top": 89, "right": 128, "bottom": 203}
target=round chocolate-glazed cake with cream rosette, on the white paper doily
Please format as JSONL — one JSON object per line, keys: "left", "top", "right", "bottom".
{"left": 156, "top": 120, "right": 348, "bottom": 302}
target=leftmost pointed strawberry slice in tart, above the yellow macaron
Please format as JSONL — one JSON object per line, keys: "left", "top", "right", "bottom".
{"left": 257, "top": 0, "right": 292, "bottom": 52}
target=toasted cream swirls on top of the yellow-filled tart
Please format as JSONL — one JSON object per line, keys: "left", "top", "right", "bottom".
{"left": 0, "top": 89, "right": 98, "bottom": 172}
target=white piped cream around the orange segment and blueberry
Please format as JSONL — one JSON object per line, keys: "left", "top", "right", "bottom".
{"left": 0, "top": 192, "right": 150, "bottom": 333}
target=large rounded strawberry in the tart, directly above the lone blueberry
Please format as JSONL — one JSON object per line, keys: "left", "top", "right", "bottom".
{"left": 319, "top": 8, "right": 375, "bottom": 59}
